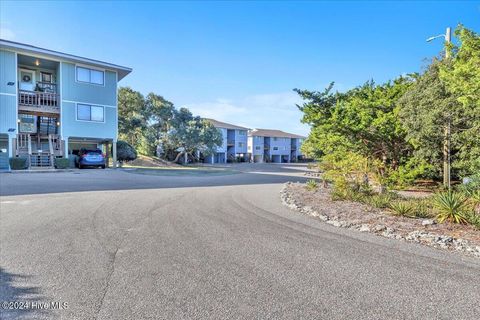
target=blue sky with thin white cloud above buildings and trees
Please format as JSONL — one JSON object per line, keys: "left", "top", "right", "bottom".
{"left": 0, "top": 0, "right": 480, "bottom": 134}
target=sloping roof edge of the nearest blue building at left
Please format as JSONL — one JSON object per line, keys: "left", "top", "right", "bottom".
{"left": 0, "top": 39, "right": 132, "bottom": 81}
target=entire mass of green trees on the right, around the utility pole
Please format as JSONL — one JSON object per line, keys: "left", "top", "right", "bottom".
{"left": 294, "top": 26, "right": 480, "bottom": 189}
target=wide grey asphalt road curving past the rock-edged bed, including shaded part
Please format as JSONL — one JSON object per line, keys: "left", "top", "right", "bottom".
{"left": 0, "top": 165, "right": 480, "bottom": 320}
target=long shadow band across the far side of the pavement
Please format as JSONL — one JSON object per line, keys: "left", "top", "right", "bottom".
{"left": 0, "top": 164, "right": 310, "bottom": 196}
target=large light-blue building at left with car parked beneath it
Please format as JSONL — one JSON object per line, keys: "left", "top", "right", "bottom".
{"left": 0, "top": 40, "right": 132, "bottom": 169}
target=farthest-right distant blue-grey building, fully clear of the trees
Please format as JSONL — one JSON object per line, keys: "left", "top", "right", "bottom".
{"left": 248, "top": 129, "right": 305, "bottom": 163}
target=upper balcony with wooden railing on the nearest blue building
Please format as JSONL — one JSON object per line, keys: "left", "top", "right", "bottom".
{"left": 18, "top": 89, "right": 60, "bottom": 113}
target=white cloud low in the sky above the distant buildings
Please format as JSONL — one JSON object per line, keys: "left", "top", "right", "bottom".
{"left": 183, "top": 91, "right": 309, "bottom": 135}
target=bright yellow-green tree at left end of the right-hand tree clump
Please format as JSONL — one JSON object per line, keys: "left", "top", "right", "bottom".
{"left": 295, "top": 77, "right": 412, "bottom": 170}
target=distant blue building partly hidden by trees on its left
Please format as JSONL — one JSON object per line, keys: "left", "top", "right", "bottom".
{"left": 204, "top": 119, "right": 248, "bottom": 163}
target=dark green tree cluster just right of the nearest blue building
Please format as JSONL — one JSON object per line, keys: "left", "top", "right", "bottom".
{"left": 118, "top": 88, "right": 222, "bottom": 161}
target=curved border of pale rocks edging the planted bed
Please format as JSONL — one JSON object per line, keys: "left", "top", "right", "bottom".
{"left": 280, "top": 182, "right": 480, "bottom": 258}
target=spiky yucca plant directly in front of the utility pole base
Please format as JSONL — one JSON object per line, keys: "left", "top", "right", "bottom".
{"left": 433, "top": 190, "right": 468, "bottom": 223}
